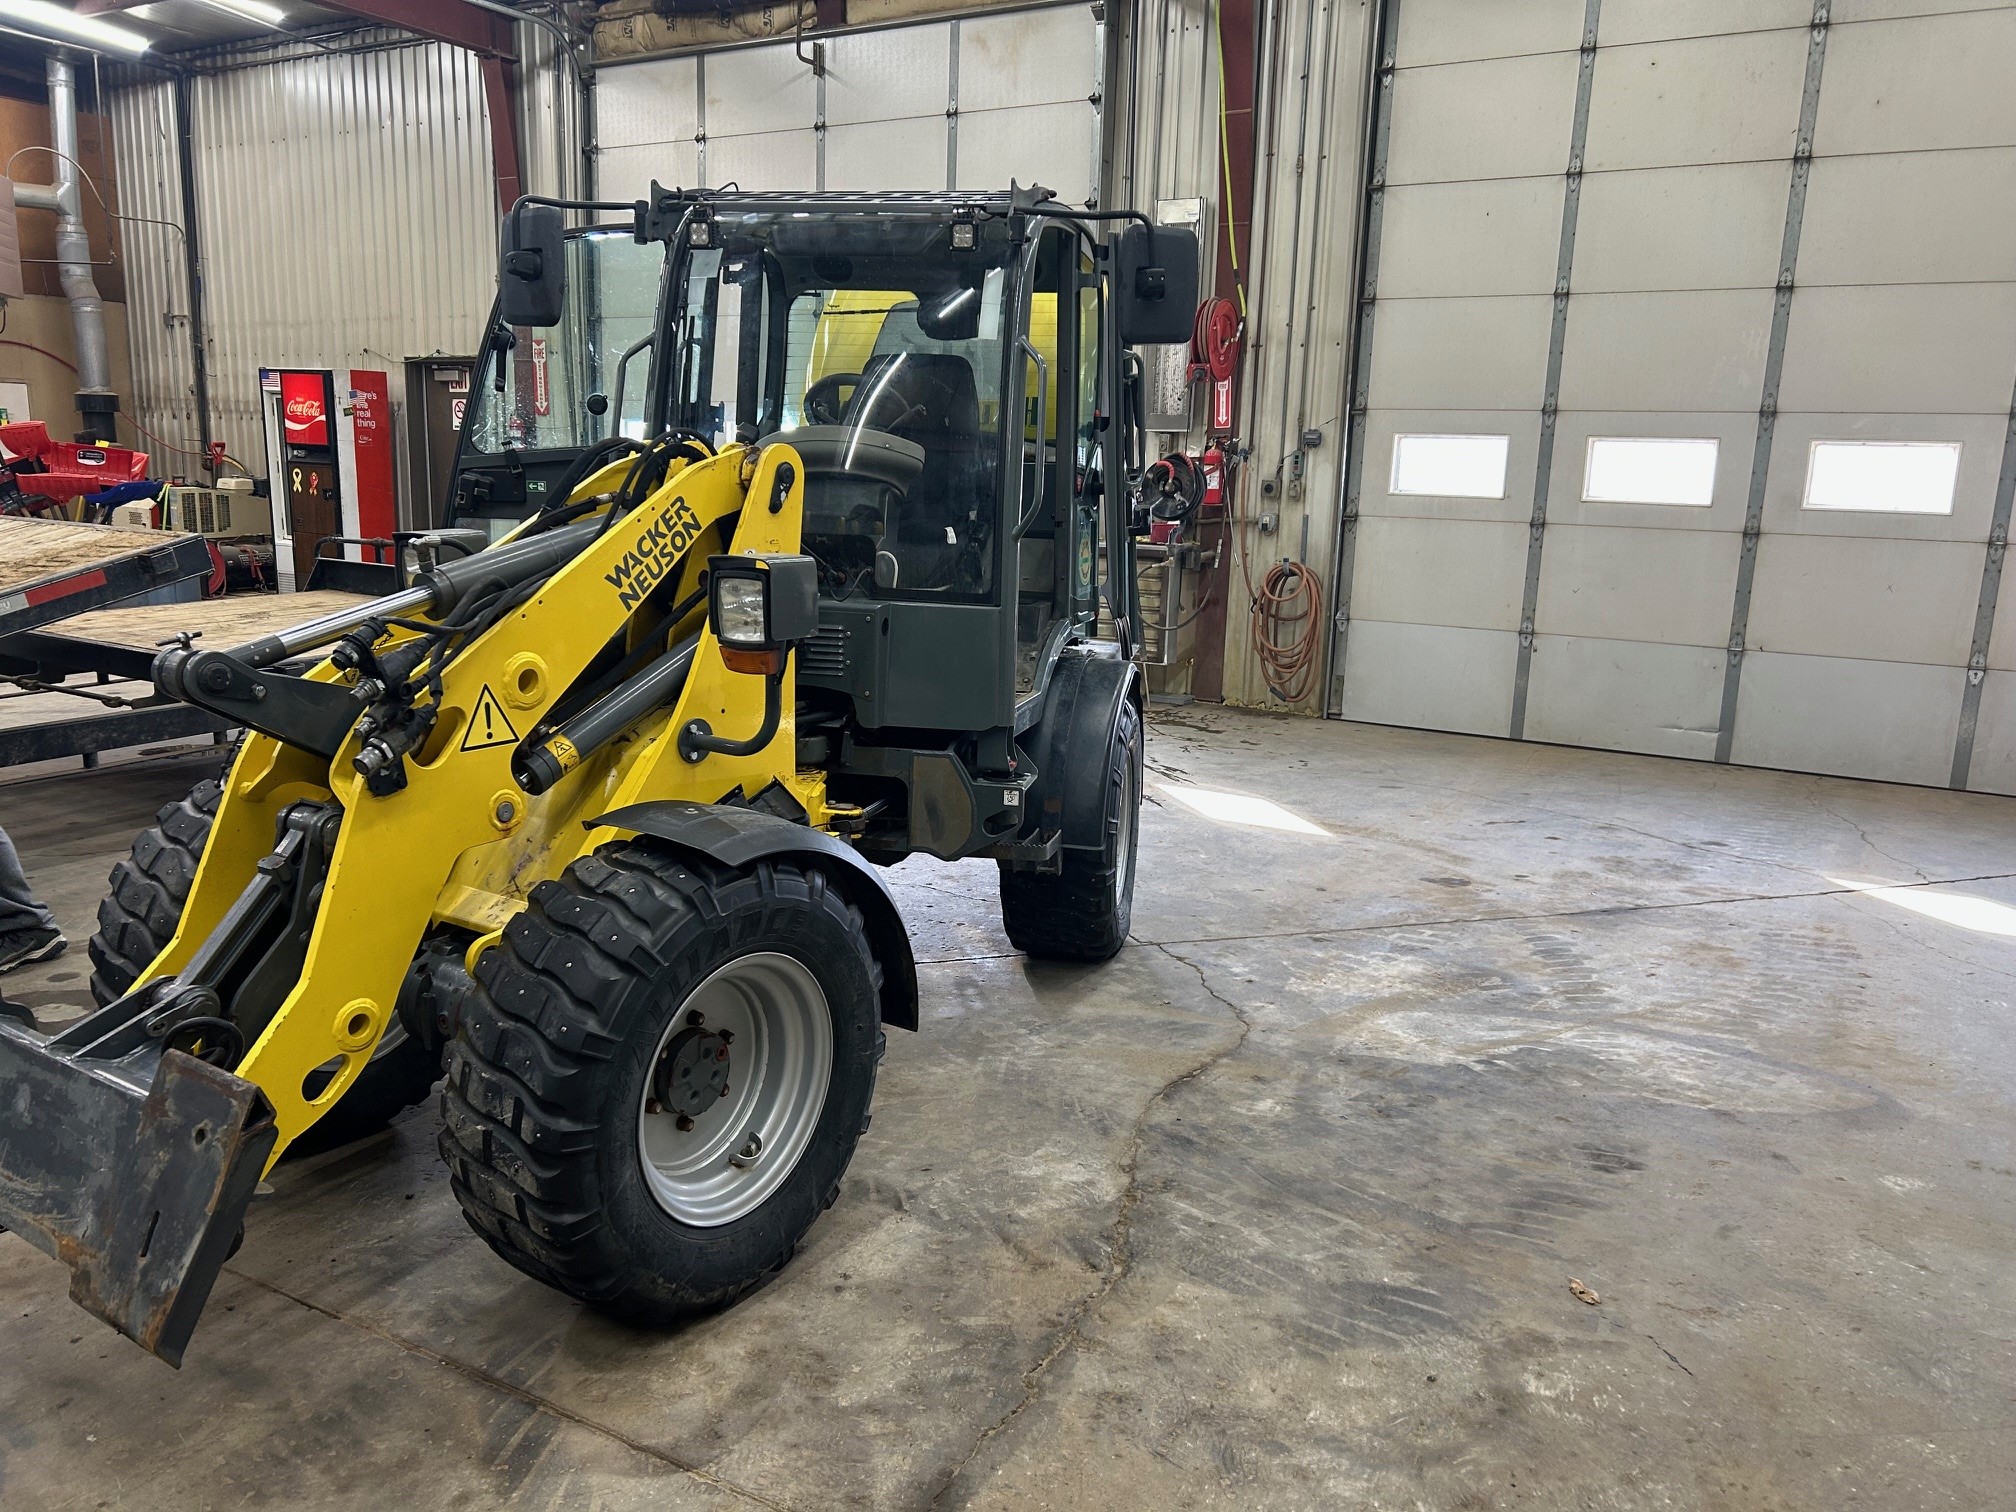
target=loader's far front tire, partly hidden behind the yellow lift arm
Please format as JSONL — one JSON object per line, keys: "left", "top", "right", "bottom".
{"left": 89, "top": 778, "right": 442, "bottom": 1155}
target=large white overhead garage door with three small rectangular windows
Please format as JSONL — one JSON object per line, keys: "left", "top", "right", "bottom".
{"left": 1333, "top": 0, "right": 2016, "bottom": 792}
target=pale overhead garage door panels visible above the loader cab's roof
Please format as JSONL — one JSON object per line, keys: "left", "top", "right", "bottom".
{"left": 595, "top": 4, "right": 1101, "bottom": 204}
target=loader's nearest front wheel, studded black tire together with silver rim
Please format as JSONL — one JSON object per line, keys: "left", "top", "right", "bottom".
{"left": 442, "top": 843, "right": 883, "bottom": 1325}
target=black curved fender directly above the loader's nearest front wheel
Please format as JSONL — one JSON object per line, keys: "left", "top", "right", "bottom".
{"left": 587, "top": 798, "right": 917, "bottom": 1030}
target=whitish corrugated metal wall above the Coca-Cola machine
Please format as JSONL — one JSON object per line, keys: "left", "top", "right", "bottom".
{"left": 111, "top": 28, "right": 560, "bottom": 510}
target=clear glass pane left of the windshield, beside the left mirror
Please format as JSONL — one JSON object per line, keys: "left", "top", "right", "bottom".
{"left": 468, "top": 230, "right": 665, "bottom": 454}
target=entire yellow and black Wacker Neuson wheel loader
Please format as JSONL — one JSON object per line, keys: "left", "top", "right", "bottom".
{"left": 0, "top": 183, "right": 1198, "bottom": 1363}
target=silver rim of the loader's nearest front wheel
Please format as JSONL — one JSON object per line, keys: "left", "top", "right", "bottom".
{"left": 637, "top": 952, "right": 833, "bottom": 1228}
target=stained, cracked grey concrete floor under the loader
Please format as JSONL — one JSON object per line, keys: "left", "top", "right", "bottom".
{"left": 0, "top": 710, "right": 2016, "bottom": 1512}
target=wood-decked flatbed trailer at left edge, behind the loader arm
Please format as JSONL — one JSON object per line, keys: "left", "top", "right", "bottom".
{"left": 0, "top": 516, "right": 363, "bottom": 768}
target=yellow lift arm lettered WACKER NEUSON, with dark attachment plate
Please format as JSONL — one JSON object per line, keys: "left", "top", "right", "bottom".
{"left": 0, "top": 435, "right": 830, "bottom": 1363}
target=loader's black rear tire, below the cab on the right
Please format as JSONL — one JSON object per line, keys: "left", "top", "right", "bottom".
{"left": 1002, "top": 698, "right": 1143, "bottom": 962}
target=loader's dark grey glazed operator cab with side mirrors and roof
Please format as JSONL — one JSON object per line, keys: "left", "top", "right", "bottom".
{"left": 452, "top": 185, "right": 1198, "bottom": 830}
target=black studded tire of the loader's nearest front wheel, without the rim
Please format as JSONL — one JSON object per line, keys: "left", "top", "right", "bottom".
{"left": 442, "top": 841, "right": 883, "bottom": 1325}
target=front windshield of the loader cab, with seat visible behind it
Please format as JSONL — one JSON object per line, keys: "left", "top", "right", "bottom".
{"left": 673, "top": 212, "right": 1012, "bottom": 599}
